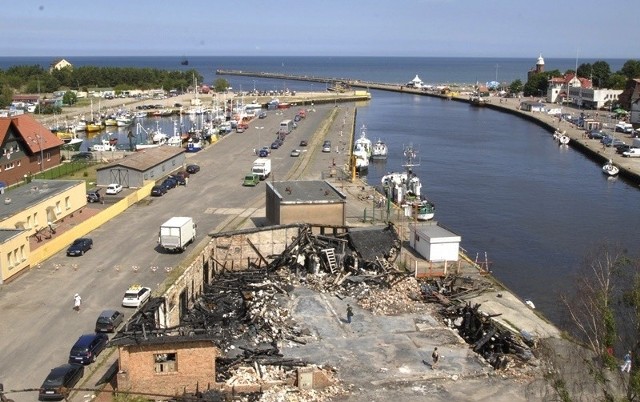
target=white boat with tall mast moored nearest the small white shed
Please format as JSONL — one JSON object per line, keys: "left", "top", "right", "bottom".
{"left": 381, "top": 145, "right": 436, "bottom": 221}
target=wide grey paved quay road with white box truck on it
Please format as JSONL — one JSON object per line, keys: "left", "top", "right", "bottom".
{"left": 0, "top": 105, "right": 346, "bottom": 402}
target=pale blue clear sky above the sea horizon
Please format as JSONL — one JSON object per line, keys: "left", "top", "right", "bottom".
{"left": 0, "top": 0, "right": 640, "bottom": 59}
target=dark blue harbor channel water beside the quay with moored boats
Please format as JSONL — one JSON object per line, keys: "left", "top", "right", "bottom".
{"left": 356, "top": 91, "right": 640, "bottom": 324}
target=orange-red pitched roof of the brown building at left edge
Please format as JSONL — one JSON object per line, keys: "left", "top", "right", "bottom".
{"left": 0, "top": 114, "right": 64, "bottom": 153}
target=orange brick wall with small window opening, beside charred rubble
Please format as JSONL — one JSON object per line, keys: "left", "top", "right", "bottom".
{"left": 118, "top": 341, "right": 218, "bottom": 395}
